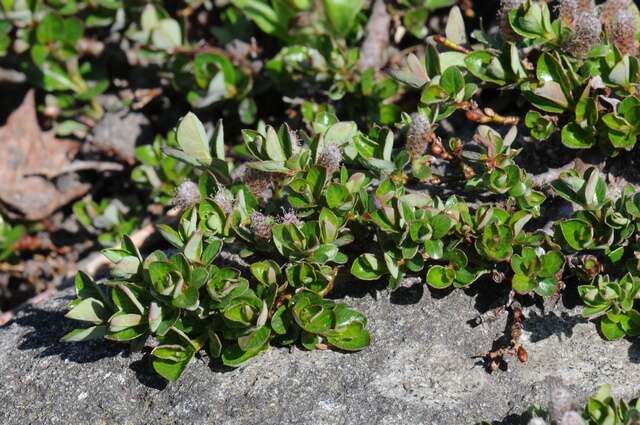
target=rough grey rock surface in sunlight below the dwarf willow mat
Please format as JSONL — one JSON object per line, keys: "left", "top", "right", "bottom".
{"left": 0, "top": 285, "right": 640, "bottom": 425}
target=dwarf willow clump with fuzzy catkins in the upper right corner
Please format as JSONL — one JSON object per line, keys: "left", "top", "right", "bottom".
{"left": 394, "top": 0, "right": 640, "bottom": 154}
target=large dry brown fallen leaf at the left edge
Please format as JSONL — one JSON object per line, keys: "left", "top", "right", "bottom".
{"left": 0, "top": 90, "right": 90, "bottom": 220}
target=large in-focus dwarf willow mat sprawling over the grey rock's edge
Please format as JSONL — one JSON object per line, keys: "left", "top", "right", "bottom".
{"left": 64, "top": 107, "right": 640, "bottom": 380}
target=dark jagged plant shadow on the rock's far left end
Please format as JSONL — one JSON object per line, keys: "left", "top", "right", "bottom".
{"left": 13, "top": 306, "right": 125, "bottom": 363}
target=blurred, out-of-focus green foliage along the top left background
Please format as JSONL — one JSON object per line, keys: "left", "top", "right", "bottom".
{"left": 0, "top": 0, "right": 455, "bottom": 131}
